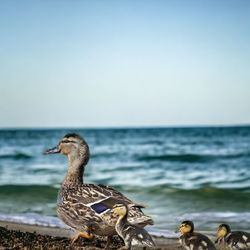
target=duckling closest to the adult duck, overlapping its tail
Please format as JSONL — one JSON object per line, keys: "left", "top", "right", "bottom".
{"left": 113, "top": 204, "right": 155, "bottom": 249}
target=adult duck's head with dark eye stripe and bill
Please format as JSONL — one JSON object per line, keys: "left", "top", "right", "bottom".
{"left": 44, "top": 133, "right": 89, "bottom": 163}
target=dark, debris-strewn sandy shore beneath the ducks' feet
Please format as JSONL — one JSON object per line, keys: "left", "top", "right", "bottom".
{"left": 0, "top": 221, "right": 182, "bottom": 250}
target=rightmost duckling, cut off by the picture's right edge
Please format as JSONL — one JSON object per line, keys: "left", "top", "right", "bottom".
{"left": 215, "top": 223, "right": 250, "bottom": 250}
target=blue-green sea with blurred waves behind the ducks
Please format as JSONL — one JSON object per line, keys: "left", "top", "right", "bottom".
{"left": 0, "top": 127, "right": 250, "bottom": 235}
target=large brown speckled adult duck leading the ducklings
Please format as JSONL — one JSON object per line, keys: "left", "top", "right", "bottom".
{"left": 45, "top": 134, "right": 153, "bottom": 247}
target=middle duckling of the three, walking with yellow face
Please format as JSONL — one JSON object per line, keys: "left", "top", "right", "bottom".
{"left": 179, "top": 220, "right": 216, "bottom": 250}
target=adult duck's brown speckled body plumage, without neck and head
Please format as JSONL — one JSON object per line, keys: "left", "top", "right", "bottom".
{"left": 57, "top": 184, "right": 153, "bottom": 235}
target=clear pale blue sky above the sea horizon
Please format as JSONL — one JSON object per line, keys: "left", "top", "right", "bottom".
{"left": 0, "top": 0, "right": 250, "bottom": 127}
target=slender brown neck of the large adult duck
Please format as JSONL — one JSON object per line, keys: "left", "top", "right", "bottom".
{"left": 63, "top": 152, "right": 88, "bottom": 186}
